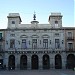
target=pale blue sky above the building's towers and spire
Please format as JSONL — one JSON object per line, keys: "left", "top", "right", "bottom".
{"left": 0, "top": 0, "right": 75, "bottom": 29}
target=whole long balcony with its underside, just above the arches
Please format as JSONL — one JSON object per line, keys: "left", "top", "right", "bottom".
{"left": 5, "top": 48, "right": 66, "bottom": 54}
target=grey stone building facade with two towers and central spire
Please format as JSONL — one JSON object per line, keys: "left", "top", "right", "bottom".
{"left": 0, "top": 13, "right": 75, "bottom": 70}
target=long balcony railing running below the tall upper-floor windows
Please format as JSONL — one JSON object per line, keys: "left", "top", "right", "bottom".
{"left": 5, "top": 48, "right": 65, "bottom": 53}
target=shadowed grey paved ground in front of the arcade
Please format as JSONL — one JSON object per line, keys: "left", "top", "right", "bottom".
{"left": 0, "top": 69, "right": 75, "bottom": 75}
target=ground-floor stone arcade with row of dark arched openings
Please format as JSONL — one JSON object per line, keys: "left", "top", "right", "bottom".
{"left": 4, "top": 53, "right": 75, "bottom": 70}
